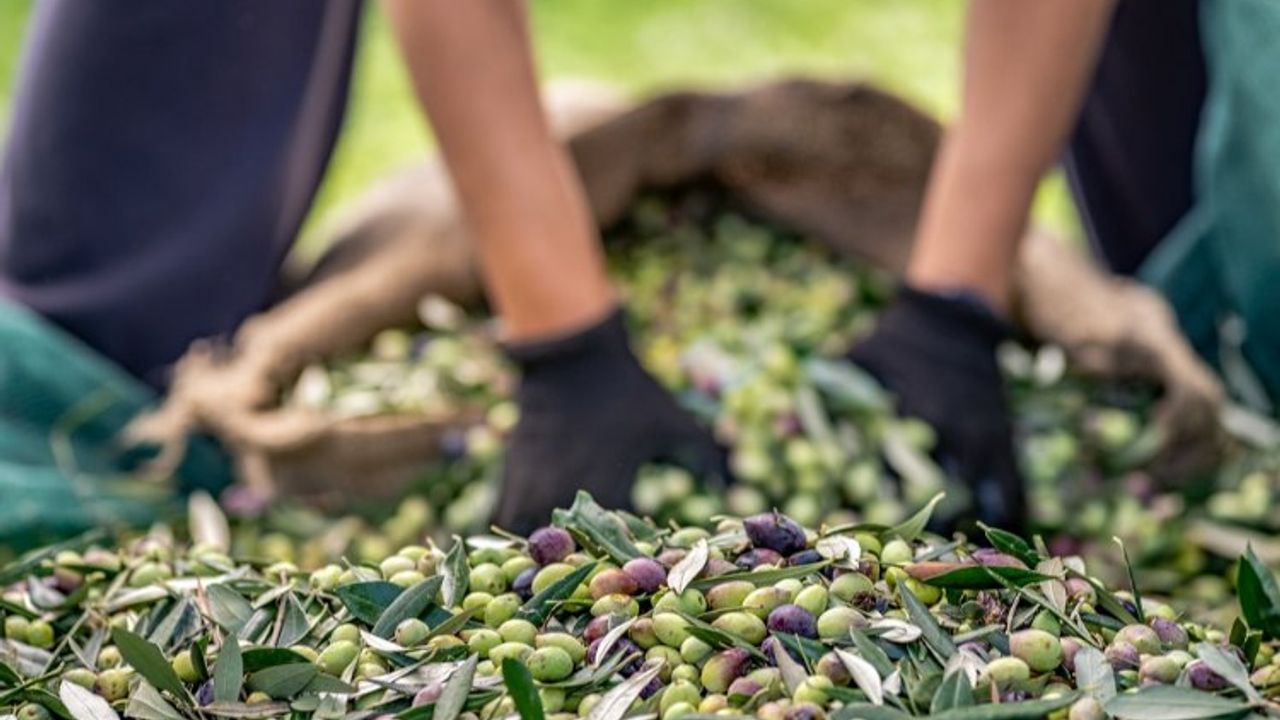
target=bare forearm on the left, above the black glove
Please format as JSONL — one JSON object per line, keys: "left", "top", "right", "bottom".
{"left": 385, "top": 0, "right": 614, "bottom": 341}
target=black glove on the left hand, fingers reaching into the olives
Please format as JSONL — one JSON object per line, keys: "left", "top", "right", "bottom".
{"left": 495, "top": 304, "right": 726, "bottom": 533}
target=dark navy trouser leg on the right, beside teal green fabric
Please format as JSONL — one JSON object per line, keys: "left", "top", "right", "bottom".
{"left": 1065, "top": 0, "right": 1206, "bottom": 274}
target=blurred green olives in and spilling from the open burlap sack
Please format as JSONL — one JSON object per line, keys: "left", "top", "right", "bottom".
{"left": 275, "top": 196, "right": 1280, "bottom": 584}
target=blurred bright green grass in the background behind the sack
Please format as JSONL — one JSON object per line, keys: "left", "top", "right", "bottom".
{"left": 0, "top": 0, "right": 1078, "bottom": 255}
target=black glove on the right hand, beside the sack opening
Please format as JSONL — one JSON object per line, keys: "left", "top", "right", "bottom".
{"left": 850, "top": 287, "right": 1025, "bottom": 530}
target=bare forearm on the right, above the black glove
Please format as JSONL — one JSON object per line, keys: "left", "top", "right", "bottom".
{"left": 908, "top": 0, "right": 1115, "bottom": 310}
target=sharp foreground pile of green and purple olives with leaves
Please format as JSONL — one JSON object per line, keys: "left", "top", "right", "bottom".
{"left": 0, "top": 495, "right": 1280, "bottom": 720}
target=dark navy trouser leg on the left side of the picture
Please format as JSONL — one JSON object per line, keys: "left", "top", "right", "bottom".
{"left": 0, "top": 0, "right": 360, "bottom": 384}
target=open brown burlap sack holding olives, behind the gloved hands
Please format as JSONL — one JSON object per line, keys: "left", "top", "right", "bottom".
{"left": 136, "top": 81, "right": 1221, "bottom": 502}
